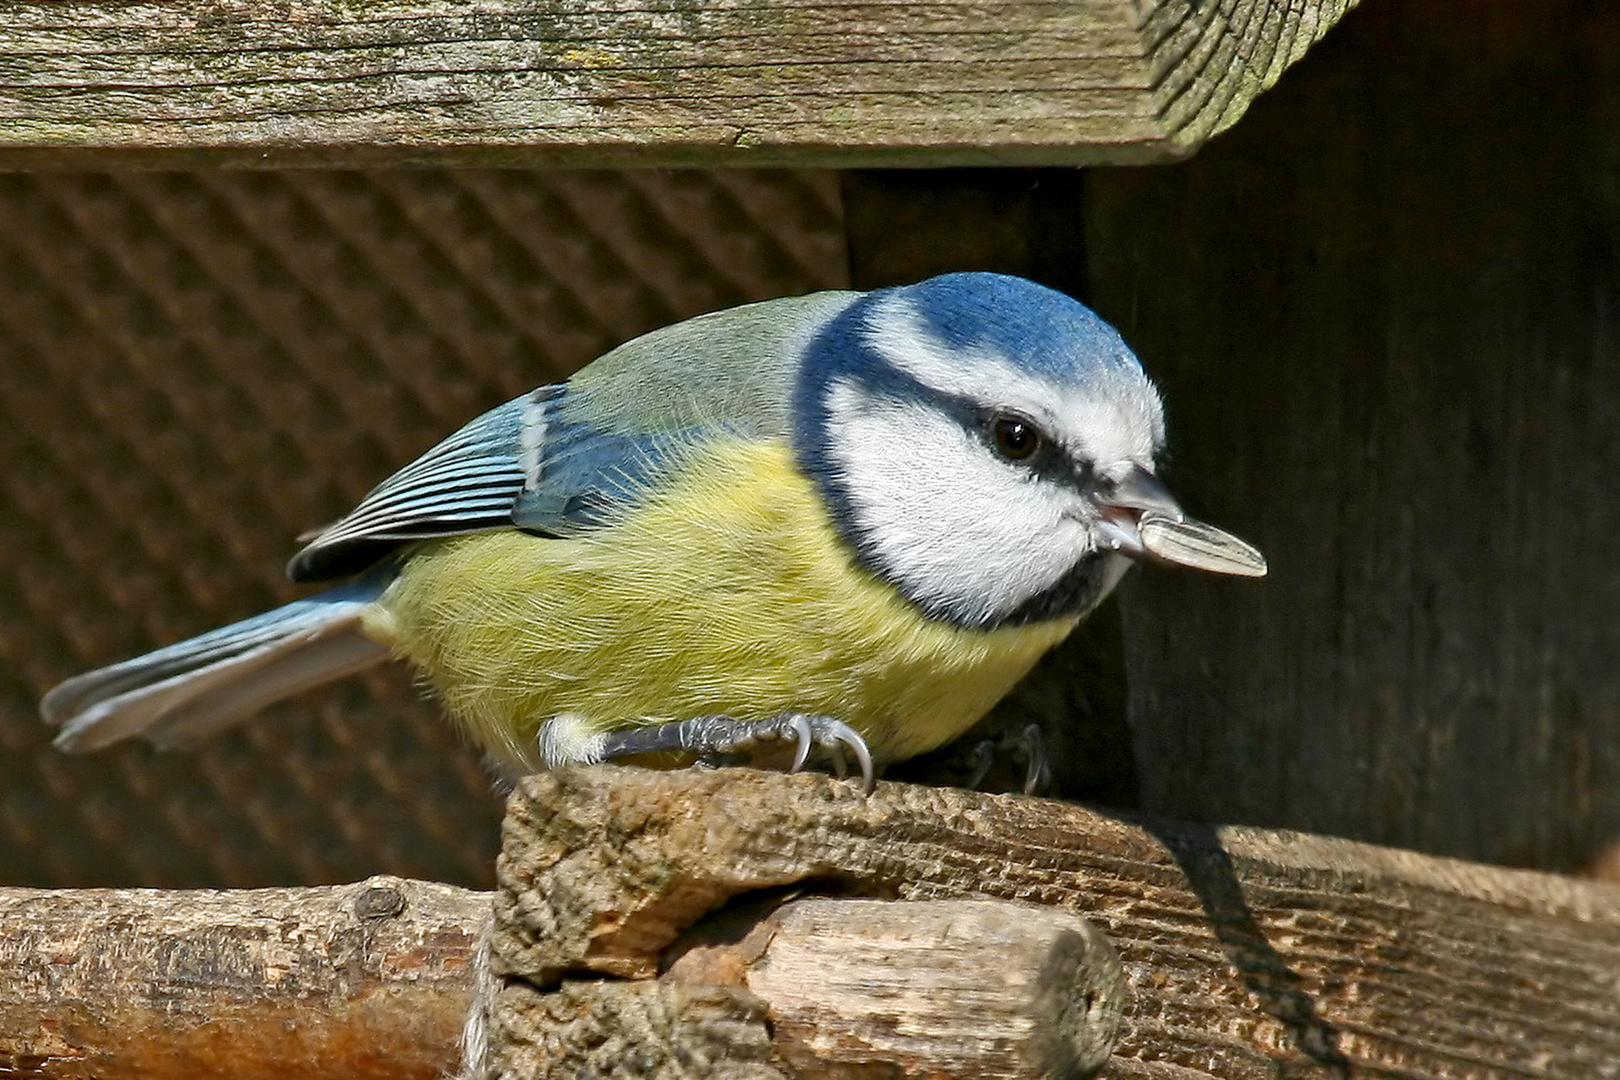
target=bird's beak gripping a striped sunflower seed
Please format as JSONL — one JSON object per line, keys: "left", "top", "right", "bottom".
{"left": 1097, "top": 468, "right": 1265, "bottom": 578}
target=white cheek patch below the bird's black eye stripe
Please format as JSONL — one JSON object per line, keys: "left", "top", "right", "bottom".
{"left": 828, "top": 381, "right": 1090, "bottom": 622}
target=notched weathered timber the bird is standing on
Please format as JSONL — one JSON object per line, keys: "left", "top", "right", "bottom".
{"left": 492, "top": 767, "right": 1620, "bottom": 1080}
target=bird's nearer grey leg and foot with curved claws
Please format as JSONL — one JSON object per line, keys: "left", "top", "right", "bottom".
{"left": 598, "top": 712, "right": 876, "bottom": 795}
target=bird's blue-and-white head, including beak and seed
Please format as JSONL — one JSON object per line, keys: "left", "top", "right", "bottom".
{"left": 794, "top": 274, "right": 1265, "bottom": 627}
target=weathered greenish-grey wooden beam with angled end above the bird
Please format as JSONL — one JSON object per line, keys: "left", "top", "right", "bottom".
{"left": 0, "top": 0, "right": 1354, "bottom": 168}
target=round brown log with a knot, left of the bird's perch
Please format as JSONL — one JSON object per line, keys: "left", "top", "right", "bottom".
{"left": 0, "top": 878, "right": 489, "bottom": 1080}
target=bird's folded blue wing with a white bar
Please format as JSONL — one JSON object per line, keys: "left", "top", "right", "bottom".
{"left": 287, "top": 384, "right": 701, "bottom": 581}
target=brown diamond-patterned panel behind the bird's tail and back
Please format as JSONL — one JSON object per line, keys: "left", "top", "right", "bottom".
{"left": 0, "top": 172, "right": 847, "bottom": 887}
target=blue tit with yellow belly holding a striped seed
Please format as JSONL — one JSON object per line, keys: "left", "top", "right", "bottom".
{"left": 41, "top": 274, "right": 1265, "bottom": 785}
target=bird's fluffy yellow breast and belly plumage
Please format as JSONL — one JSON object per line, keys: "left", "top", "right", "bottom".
{"left": 366, "top": 442, "right": 1077, "bottom": 769}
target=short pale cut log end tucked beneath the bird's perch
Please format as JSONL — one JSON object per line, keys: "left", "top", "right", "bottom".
{"left": 664, "top": 899, "right": 1124, "bottom": 1080}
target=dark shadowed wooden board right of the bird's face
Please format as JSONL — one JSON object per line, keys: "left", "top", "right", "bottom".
{"left": 1085, "top": 0, "right": 1620, "bottom": 871}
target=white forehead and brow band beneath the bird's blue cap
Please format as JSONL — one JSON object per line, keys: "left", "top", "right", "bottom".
{"left": 862, "top": 296, "right": 1165, "bottom": 465}
